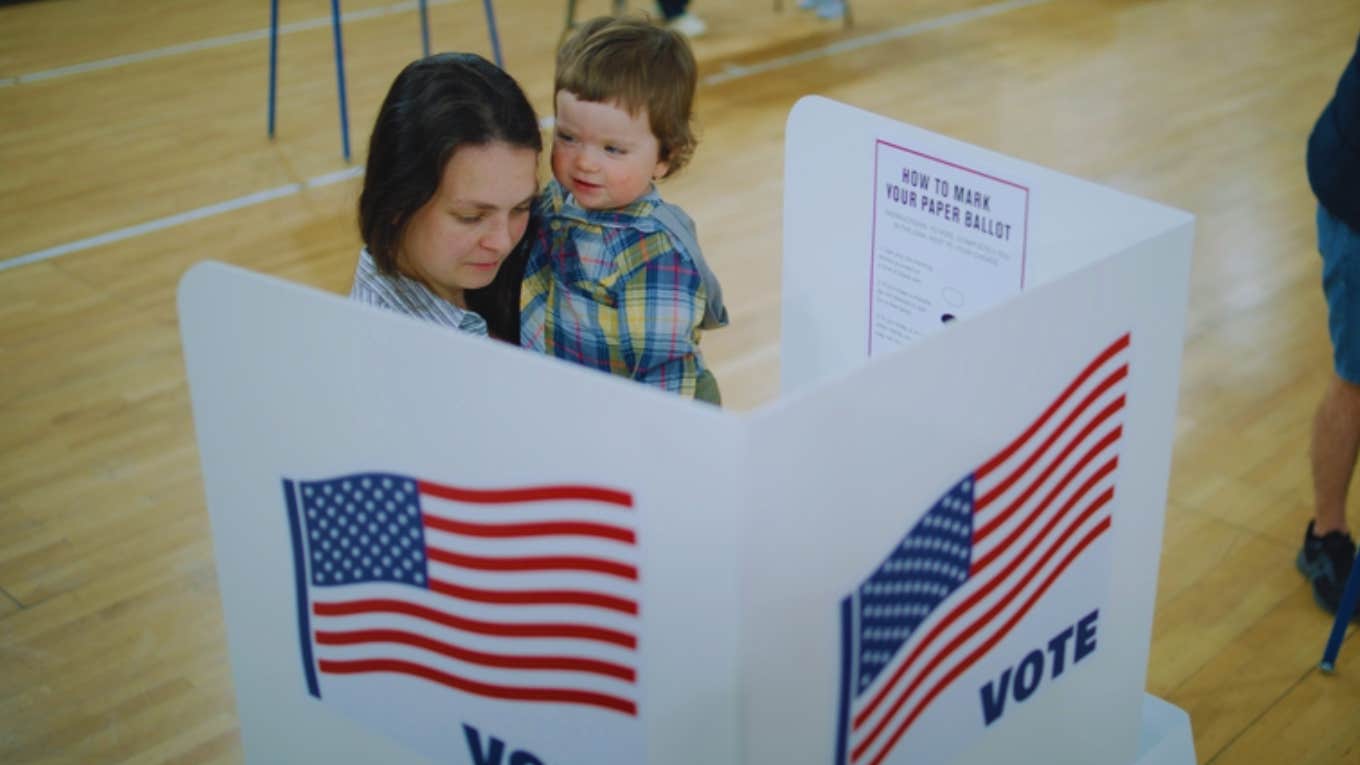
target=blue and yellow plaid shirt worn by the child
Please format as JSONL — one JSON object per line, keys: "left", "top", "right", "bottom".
{"left": 520, "top": 181, "right": 726, "bottom": 396}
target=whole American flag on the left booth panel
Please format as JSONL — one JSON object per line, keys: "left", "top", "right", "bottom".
{"left": 283, "top": 472, "right": 639, "bottom": 717}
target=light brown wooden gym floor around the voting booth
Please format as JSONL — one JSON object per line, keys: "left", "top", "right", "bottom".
{"left": 0, "top": 0, "right": 1360, "bottom": 765}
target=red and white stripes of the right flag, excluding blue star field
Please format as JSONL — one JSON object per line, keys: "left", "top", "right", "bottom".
{"left": 849, "top": 335, "right": 1129, "bottom": 765}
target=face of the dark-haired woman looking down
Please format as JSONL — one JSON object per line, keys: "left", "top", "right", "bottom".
{"left": 397, "top": 142, "right": 539, "bottom": 308}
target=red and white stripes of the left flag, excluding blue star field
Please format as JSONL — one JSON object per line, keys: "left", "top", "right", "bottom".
{"left": 311, "top": 482, "right": 641, "bottom": 716}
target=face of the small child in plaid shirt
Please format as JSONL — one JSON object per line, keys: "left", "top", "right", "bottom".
{"left": 552, "top": 90, "right": 668, "bottom": 210}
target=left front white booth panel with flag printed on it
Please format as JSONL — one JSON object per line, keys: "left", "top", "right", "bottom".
{"left": 181, "top": 272, "right": 744, "bottom": 764}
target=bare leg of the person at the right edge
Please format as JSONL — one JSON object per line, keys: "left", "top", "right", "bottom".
{"left": 1312, "top": 373, "right": 1360, "bottom": 536}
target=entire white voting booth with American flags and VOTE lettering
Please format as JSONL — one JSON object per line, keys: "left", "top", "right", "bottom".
{"left": 180, "top": 98, "right": 1194, "bottom": 765}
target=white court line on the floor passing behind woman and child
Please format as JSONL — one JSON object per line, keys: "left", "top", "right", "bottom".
{"left": 0, "top": 0, "right": 1051, "bottom": 272}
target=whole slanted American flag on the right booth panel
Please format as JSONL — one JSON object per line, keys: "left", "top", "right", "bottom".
{"left": 835, "top": 333, "right": 1129, "bottom": 765}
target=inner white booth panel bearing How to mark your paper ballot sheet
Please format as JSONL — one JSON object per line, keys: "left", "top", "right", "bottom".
{"left": 781, "top": 97, "right": 1193, "bottom": 391}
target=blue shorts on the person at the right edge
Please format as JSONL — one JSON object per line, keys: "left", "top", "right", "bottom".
{"left": 1318, "top": 204, "right": 1360, "bottom": 385}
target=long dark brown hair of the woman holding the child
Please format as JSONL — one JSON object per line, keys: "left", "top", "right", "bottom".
{"left": 359, "top": 53, "right": 543, "bottom": 342}
